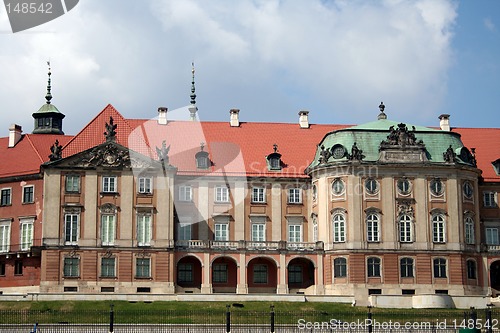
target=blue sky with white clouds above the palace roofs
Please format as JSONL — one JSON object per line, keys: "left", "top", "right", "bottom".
{"left": 0, "top": 0, "right": 500, "bottom": 136}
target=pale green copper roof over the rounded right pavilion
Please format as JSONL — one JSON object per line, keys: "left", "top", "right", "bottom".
{"left": 309, "top": 119, "right": 470, "bottom": 168}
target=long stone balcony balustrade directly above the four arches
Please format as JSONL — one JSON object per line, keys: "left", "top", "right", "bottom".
{"left": 175, "top": 240, "right": 324, "bottom": 252}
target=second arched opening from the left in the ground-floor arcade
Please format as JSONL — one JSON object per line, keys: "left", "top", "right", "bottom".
{"left": 212, "top": 257, "right": 238, "bottom": 293}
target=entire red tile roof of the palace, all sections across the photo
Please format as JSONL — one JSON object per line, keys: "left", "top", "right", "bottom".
{"left": 0, "top": 105, "right": 500, "bottom": 182}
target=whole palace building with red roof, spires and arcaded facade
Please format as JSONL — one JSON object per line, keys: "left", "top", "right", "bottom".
{"left": 0, "top": 68, "right": 500, "bottom": 304}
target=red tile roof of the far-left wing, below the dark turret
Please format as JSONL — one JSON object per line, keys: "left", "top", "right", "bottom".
{"left": 0, "top": 134, "right": 71, "bottom": 178}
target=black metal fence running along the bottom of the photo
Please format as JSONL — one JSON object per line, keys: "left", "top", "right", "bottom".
{"left": 0, "top": 303, "right": 500, "bottom": 333}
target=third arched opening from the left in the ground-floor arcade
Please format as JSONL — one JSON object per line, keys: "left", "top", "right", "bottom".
{"left": 247, "top": 257, "right": 278, "bottom": 294}
